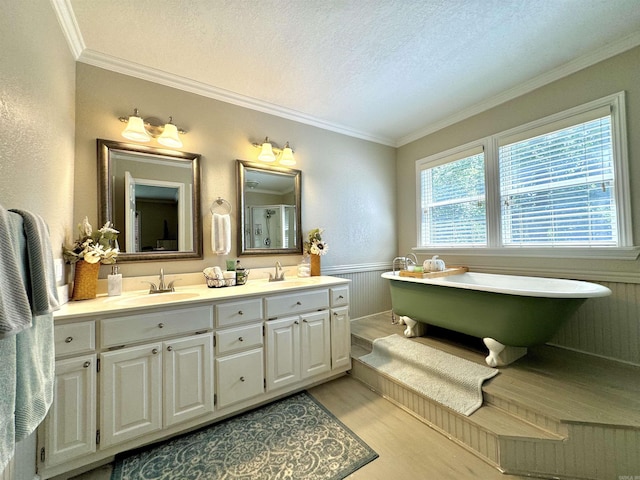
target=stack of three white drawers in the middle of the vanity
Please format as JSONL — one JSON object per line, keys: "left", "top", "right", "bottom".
{"left": 215, "top": 298, "right": 264, "bottom": 409}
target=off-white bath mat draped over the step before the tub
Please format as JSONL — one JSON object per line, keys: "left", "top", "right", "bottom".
{"left": 360, "top": 334, "right": 499, "bottom": 416}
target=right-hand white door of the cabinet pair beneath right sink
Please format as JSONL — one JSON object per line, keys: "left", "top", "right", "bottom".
{"left": 300, "top": 310, "right": 331, "bottom": 378}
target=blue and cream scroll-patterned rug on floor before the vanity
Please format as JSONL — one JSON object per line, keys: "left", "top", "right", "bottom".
{"left": 111, "top": 392, "right": 378, "bottom": 480}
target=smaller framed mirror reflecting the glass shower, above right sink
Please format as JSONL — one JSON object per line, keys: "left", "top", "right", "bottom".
{"left": 237, "top": 160, "right": 302, "bottom": 255}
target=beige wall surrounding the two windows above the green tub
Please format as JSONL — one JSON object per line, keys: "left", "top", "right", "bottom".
{"left": 397, "top": 48, "right": 640, "bottom": 282}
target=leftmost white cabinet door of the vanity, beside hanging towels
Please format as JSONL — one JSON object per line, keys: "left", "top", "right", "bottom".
{"left": 45, "top": 354, "right": 96, "bottom": 465}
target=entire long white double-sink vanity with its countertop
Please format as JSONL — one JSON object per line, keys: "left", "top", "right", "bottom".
{"left": 37, "top": 276, "right": 351, "bottom": 480}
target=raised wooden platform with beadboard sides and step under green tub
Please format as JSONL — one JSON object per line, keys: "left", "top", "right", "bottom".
{"left": 351, "top": 313, "right": 640, "bottom": 480}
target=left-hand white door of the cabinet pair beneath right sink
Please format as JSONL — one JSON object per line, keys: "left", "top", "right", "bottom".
{"left": 265, "top": 316, "right": 300, "bottom": 391}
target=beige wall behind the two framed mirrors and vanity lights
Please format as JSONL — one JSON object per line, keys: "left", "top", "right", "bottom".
{"left": 73, "top": 63, "right": 396, "bottom": 277}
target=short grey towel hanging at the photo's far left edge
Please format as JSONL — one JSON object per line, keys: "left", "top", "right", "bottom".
{"left": 0, "top": 206, "right": 31, "bottom": 338}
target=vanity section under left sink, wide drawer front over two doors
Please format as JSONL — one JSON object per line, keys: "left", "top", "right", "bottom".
{"left": 100, "top": 307, "right": 213, "bottom": 448}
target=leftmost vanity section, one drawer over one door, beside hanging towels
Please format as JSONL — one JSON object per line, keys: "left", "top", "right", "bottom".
{"left": 38, "top": 321, "right": 97, "bottom": 466}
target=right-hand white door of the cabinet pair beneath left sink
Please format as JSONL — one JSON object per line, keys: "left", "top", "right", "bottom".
{"left": 162, "top": 333, "right": 213, "bottom": 427}
